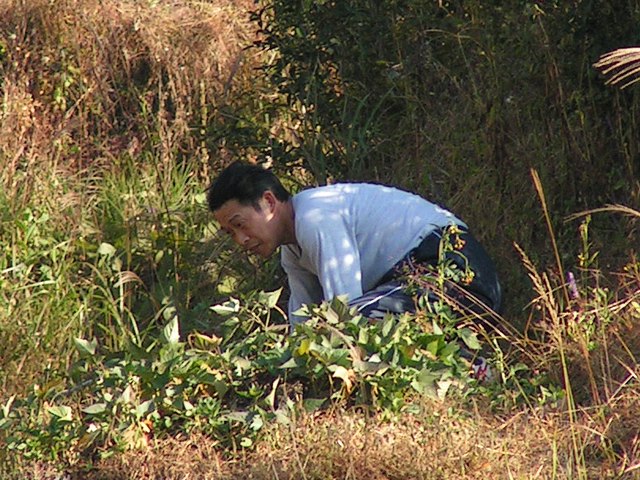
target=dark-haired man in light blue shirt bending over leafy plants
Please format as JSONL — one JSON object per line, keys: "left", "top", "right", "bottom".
{"left": 208, "top": 162, "right": 502, "bottom": 325}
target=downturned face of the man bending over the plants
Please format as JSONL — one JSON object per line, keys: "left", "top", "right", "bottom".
{"left": 213, "top": 192, "right": 281, "bottom": 258}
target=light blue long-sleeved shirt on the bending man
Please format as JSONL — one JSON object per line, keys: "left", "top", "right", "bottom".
{"left": 281, "top": 183, "right": 466, "bottom": 324}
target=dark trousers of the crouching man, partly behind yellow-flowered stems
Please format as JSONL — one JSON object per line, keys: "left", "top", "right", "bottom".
{"left": 349, "top": 228, "right": 502, "bottom": 318}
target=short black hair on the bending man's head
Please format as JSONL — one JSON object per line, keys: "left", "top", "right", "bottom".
{"left": 207, "top": 161, "right": 290, "bottom": 212}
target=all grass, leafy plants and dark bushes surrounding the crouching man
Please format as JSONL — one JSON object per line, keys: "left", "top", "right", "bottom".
{"left": 0, "top": 0, "right": 640, "bottom": 479}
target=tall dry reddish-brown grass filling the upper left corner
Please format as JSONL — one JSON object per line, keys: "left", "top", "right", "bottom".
{"left": 0, "top": 0, "right": 255, "bottom": 184}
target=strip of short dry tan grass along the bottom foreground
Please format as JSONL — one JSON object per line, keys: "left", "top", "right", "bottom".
{"left": 17, "top": 392, "right": 640, "bottom": 480}
